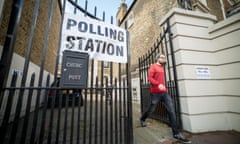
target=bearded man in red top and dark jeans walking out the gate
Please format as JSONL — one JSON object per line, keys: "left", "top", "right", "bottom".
{"left": 140, "top": 54, "right": 191, "bottom": 143}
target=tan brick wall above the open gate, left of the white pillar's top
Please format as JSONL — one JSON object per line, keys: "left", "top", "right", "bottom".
{"left": 117, "top": 0, "right": 177, "bottom": 71}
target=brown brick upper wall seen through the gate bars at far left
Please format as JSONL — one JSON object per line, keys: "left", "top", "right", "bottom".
{"left": 0, "top": 0, "right": 61, "bottom": 73}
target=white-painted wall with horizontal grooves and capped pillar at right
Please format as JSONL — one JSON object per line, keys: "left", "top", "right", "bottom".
{"left": 160, "top": 8, "right": 240, "bottom": 133}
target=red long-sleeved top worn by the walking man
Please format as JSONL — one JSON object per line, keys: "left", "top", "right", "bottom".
{"left": 148, "top": 63, "right": 167, "bottom": 93}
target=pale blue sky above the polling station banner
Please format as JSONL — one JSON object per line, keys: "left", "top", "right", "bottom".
{"left": 66, "top": 0, "right": 133, "bottom": 24}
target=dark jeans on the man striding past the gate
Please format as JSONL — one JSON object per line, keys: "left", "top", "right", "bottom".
{"left": 141, "top": 93, "right": 179, "bottom": 135}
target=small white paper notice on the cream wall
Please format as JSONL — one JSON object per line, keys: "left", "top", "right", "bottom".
{"left": 195, "top": 66, "right": 211, "bottom": 79}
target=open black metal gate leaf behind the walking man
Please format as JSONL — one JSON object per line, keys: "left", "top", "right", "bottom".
{"left": 139, "top": 20, "right": 181, "bottom": 128}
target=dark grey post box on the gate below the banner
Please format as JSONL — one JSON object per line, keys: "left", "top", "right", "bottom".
{"left": 60, "top": 51, "right": 89, "bottom": 89}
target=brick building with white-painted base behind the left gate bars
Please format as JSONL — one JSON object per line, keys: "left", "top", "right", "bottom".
{"left": 0, "top": 0, "right": 62, "bottom": 121}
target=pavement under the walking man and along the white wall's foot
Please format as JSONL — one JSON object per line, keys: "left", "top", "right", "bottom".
{"left": 132, "top": 101, "right": 240, "bottom": 144}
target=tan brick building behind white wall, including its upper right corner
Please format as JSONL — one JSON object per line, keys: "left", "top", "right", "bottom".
{"left": 116, "top": 0, "right": 240, "bottom": 71}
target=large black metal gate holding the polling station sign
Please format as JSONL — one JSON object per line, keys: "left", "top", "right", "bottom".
{"left": 0, "top": 0, "right": 133, "bottom": 144}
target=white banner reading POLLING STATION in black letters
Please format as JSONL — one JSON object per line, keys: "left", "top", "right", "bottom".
{"left": 60, "top": 13, "right": 127, "bottom": 63}
